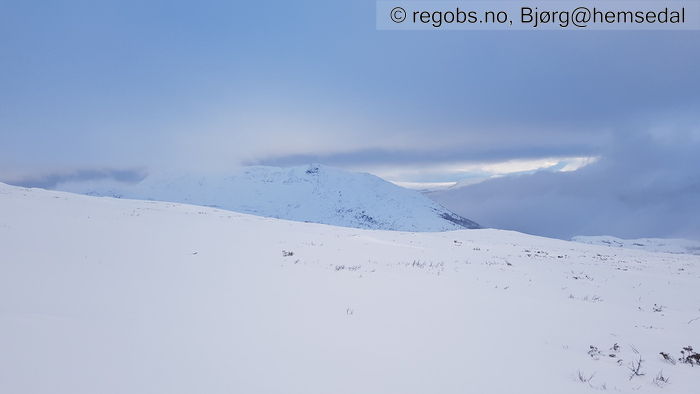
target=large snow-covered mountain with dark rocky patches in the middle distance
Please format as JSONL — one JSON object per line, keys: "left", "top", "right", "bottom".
{"left": 60, "top": 165, "right": 480, "bottom": 231}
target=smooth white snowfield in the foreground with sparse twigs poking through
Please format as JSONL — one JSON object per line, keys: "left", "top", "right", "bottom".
{"left": 0, "top": 184, "right": 700, "bottom": 394}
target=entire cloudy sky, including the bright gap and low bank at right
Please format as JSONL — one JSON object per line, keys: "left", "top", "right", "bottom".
{"left": 0, "top": 0, "right": 700, "bottom": 237}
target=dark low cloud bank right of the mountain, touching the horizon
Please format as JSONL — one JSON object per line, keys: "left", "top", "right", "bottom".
{"left": 431, "top": 121, "right": 700, "bottom": 239}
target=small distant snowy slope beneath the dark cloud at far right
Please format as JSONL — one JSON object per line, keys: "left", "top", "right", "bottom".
{"left": 571, "top": 235, "right": 700, "bottom": 255}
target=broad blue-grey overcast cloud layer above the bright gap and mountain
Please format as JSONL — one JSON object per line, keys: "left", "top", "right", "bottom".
{"left": 0, "top": 1, "right": 700, "bottom": 177}
